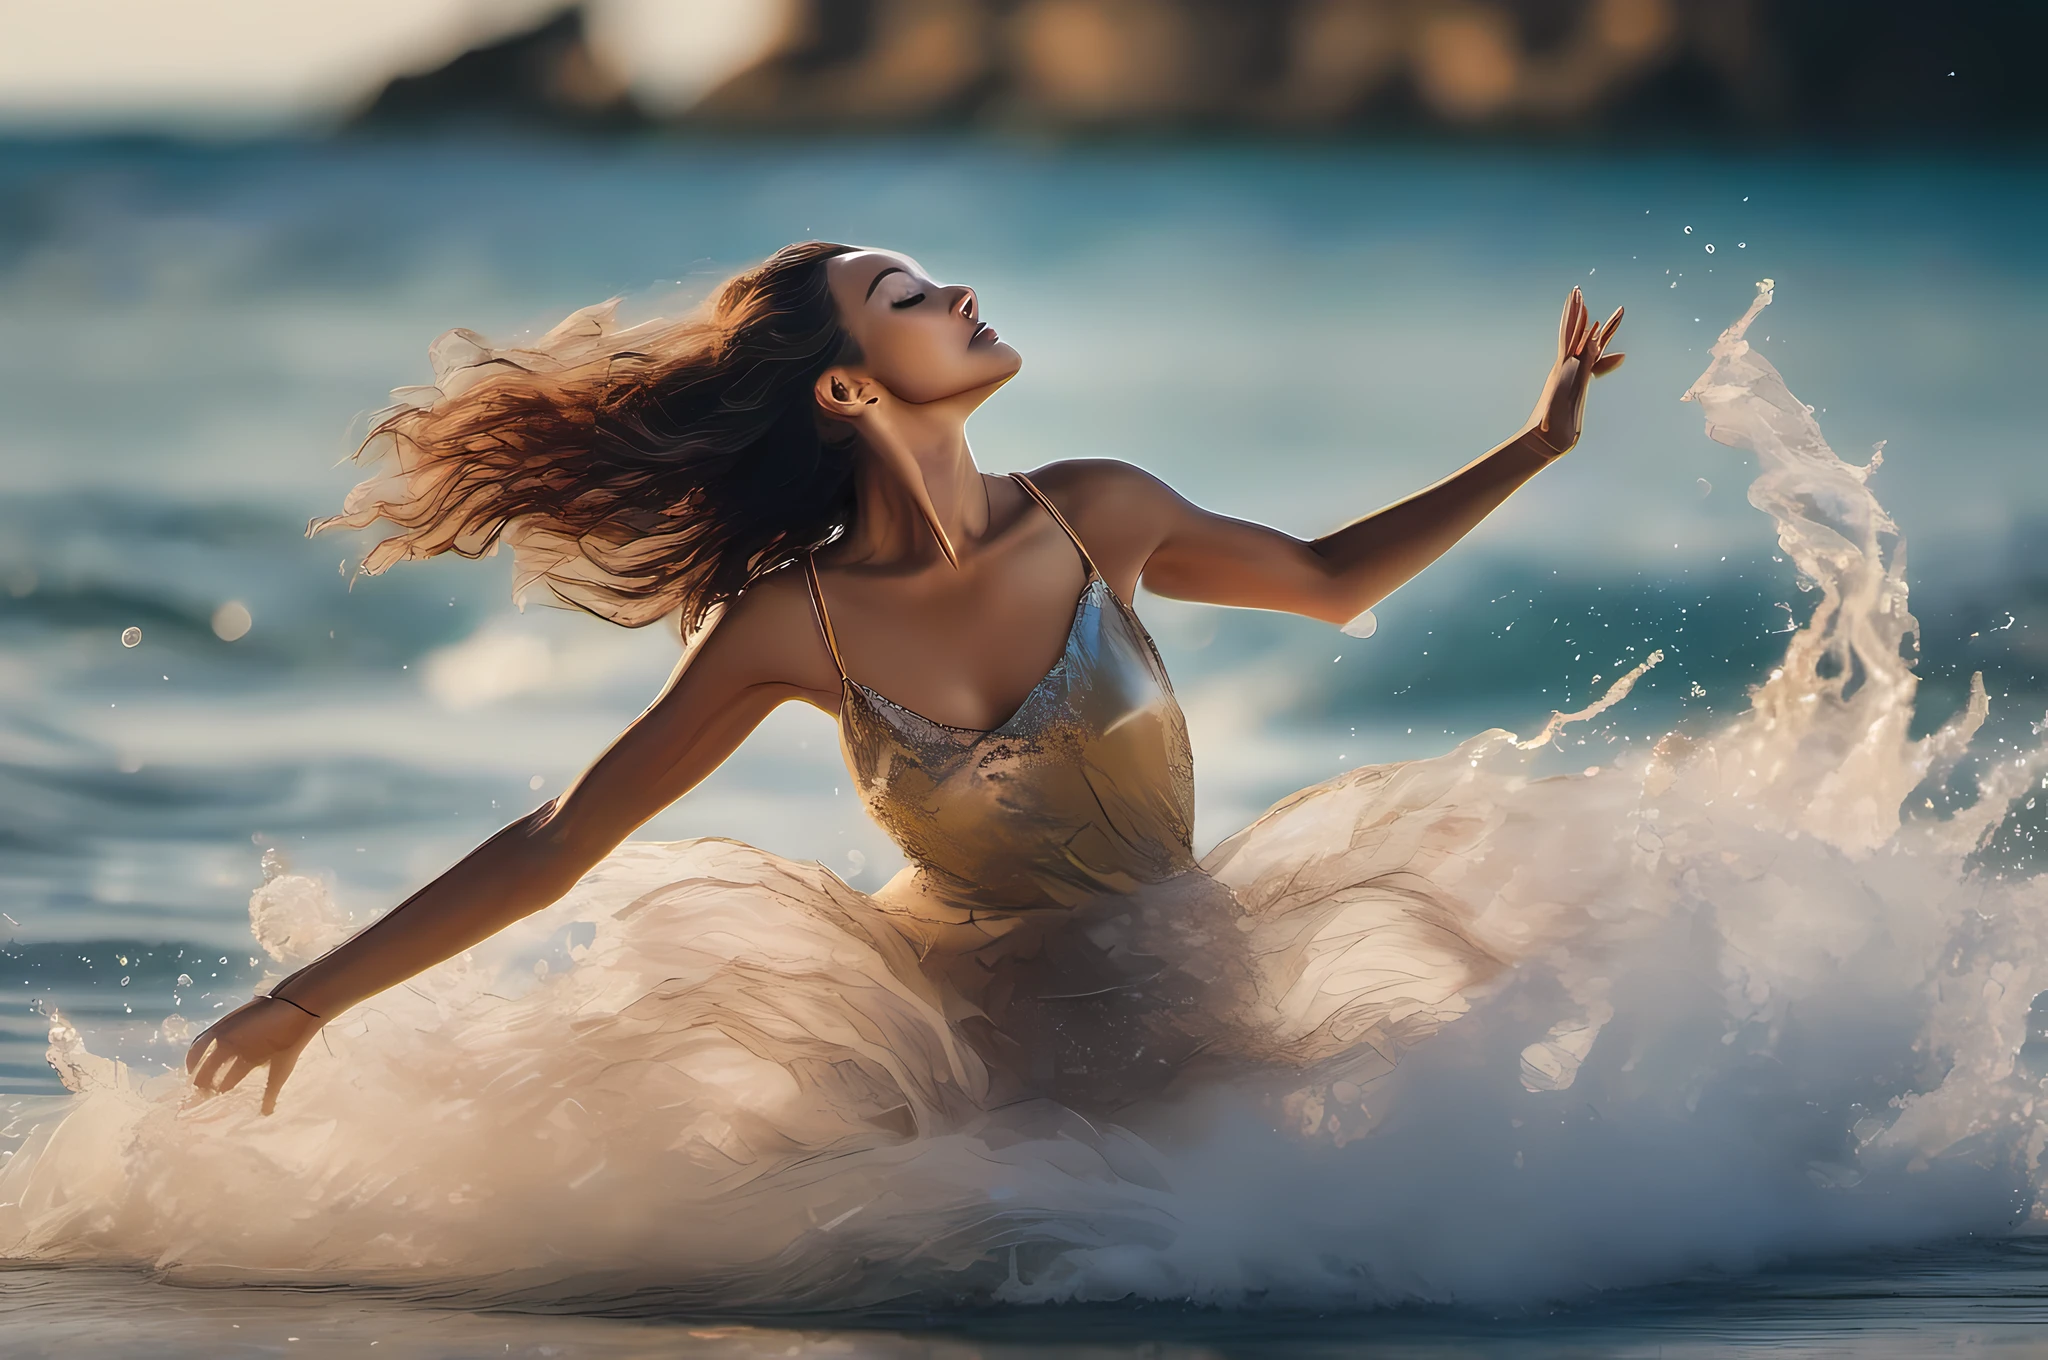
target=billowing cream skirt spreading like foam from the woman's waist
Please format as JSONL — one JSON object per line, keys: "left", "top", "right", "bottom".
{"left": 0, "top": 733, "right": 1589, "bottom": 1303}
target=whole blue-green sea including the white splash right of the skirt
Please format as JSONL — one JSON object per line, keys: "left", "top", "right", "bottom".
{"left": 0, "top": 143, "right": 2048, "bottom": 1354}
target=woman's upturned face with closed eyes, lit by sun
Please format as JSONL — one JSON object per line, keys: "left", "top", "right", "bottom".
{"left": 825, "top": 250, "right": 1024, "bottom": 406}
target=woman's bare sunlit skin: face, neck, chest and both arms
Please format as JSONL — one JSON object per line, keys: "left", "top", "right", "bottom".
{"left": 186, "top": 250, "right": 1622, "bottom": 1114}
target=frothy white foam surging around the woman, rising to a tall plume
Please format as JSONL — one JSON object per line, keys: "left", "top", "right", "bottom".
{"left": 0, "top": 289, "right": 2048, "bottom": 1307}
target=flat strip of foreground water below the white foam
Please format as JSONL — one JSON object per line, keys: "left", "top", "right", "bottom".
{"left": 0, "top": 1243, "right": 2048, "bottom": 1360}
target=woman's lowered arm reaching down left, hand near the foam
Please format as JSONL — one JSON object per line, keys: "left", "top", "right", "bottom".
{"left": 184, "top": 571, "right": 840, "bottom": 1114}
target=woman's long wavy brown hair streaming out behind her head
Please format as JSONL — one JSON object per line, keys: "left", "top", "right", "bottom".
{"left": 307, "top": 242, "right": 858, "bottom": 633}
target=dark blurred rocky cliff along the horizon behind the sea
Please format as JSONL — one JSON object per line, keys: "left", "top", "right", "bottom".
{"left": 352, "top": 0, "right": 2048, "bottom": 141}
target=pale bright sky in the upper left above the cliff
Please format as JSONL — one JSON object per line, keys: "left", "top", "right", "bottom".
{"left": 0, "top": 0, "right": 791, "bottom": 133}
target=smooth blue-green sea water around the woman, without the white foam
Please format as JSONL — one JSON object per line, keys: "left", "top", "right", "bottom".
{"left": 0, "top": 143, "right": 2048, "bottom": 1356}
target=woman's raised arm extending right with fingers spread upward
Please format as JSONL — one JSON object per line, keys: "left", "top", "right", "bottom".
{"left": 1038, "top": 289, "right": 1622, "bottom": 623}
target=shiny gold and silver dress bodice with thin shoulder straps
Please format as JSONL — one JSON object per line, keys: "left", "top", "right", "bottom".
{"left": 811, "top": 475, "right": 1194, "bottom": 916}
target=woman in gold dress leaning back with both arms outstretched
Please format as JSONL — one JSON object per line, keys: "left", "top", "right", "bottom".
{"left": 186, "top": 242, "right": 1622, "bottom": 1143}
